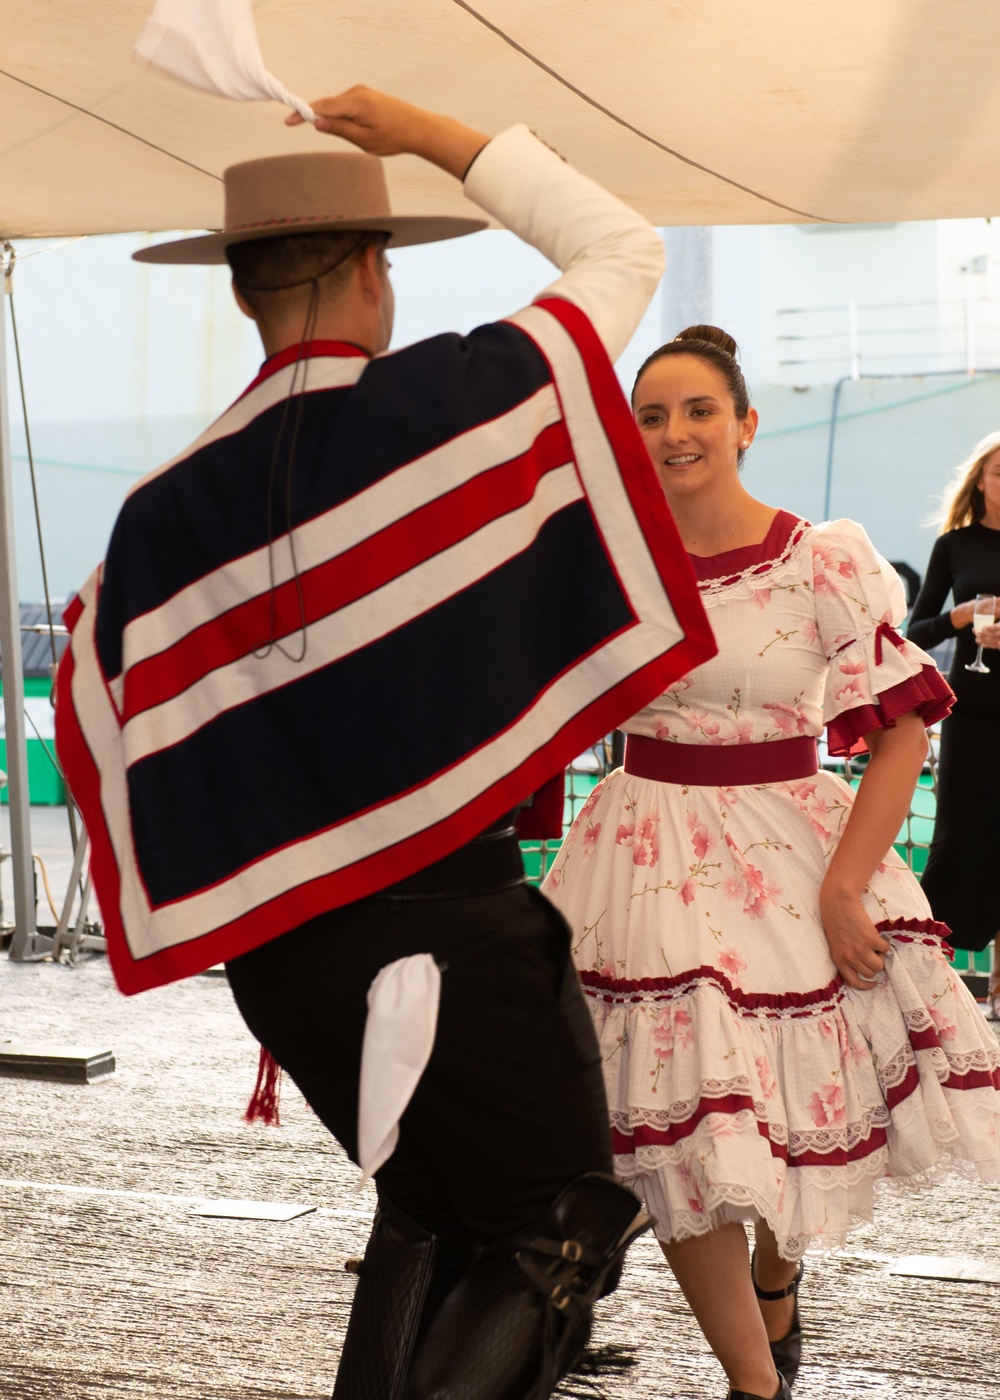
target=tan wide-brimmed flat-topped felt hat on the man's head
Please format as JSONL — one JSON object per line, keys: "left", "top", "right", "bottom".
{"left": 132, "top": 151, "right": 486, "bottom": 263}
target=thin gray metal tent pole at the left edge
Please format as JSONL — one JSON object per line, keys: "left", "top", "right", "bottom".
{"left": 0, "top": 244, "right": 38, "bottom": 960}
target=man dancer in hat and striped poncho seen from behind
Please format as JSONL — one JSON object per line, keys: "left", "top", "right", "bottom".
{"left": 56, "top": 88, "right": 713, "bottom": 1400}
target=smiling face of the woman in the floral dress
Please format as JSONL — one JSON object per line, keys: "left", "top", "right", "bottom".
{"left": 633, "top": 354, "right": 756, "bottom": 498}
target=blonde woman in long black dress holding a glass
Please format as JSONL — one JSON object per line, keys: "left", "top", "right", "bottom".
{"left": 906, "top": 433, "right": 1000, "bottom": 1021}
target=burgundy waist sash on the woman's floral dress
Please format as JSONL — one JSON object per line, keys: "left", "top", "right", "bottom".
{"left": 625, "top": 734, "right": 819, "bottom": 787}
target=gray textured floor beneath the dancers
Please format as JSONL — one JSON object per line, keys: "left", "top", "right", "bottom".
{"left": 0, "top": 815, "right": 1000, "bottom": 1400}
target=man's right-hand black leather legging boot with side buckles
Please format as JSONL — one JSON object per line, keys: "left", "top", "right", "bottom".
{"left": 405, "top": 1173, "right": 653, "bottom": 1400}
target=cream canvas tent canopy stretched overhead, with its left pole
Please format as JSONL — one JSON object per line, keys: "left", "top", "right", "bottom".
{"left": 0, "top": 0, "right": 1000, "bottom": 949}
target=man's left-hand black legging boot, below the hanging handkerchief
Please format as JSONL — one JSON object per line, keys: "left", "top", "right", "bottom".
{"left": 333, "top": 1198, "right": 473, "bottom": 1400}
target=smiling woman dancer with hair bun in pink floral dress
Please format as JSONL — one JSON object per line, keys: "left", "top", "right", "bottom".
{"left": 546, "top": 326, "right": 1000, "bottom": 1400}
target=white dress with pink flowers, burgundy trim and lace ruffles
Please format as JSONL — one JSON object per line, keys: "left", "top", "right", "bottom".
{"left": 545, "top": 512, "right": 1000, "bottom": 1259}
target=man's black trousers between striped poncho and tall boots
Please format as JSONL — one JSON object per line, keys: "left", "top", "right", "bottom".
{"left": 227, "top": 885, "right": 611, "bottom": 1240}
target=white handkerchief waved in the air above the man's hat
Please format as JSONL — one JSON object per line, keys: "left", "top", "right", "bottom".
{"left": 134, "top": 0, "right": 310, "bottom": 122}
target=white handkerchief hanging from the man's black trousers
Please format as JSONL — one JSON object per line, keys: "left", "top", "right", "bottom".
{"left": 357, "top": 953, "right": 441, "bottom": 1187}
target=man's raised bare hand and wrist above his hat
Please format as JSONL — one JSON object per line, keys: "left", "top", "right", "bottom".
{"left": 284, "top": 85, "right": 489, "bottom": 179}
